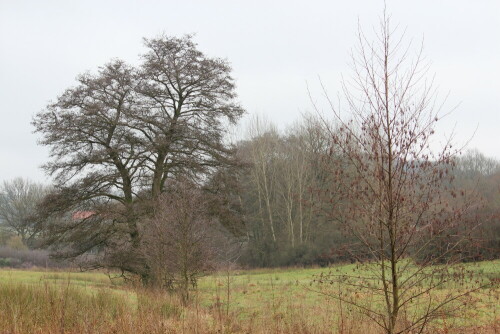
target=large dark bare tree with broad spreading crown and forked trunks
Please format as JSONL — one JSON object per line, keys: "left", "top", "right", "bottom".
{"left": 33, "top": 36, "right": 244, "bottom": 290}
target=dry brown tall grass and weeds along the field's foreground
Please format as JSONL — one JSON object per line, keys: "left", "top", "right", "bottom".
{"left": 0, "top": 268, "right": 500, "bottom": 334}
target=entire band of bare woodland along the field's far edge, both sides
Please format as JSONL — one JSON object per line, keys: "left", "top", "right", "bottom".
{"left": 0, "top": 116, "right": 500, "bottom": 267}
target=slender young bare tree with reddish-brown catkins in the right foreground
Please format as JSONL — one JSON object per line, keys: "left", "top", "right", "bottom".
{"left": 312, "top": 12, "right": 480, "bottom": 334}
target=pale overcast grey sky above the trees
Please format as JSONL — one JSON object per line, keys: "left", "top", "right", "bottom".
{"left": 0, "top": 0, "right": 500, "bottom": 182}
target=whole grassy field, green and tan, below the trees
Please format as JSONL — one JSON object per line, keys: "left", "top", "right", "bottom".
{"left": 0, "top": 261, "right": 500, "bottom": 334}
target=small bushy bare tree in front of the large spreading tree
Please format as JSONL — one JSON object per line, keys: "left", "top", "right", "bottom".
{"left": 141, "top": 181, "right": 224, "bottom": 301}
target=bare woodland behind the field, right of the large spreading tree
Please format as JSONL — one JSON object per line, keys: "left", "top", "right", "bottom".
{"left": 238, "top": 116, "right": 500, "bottom": 267}
